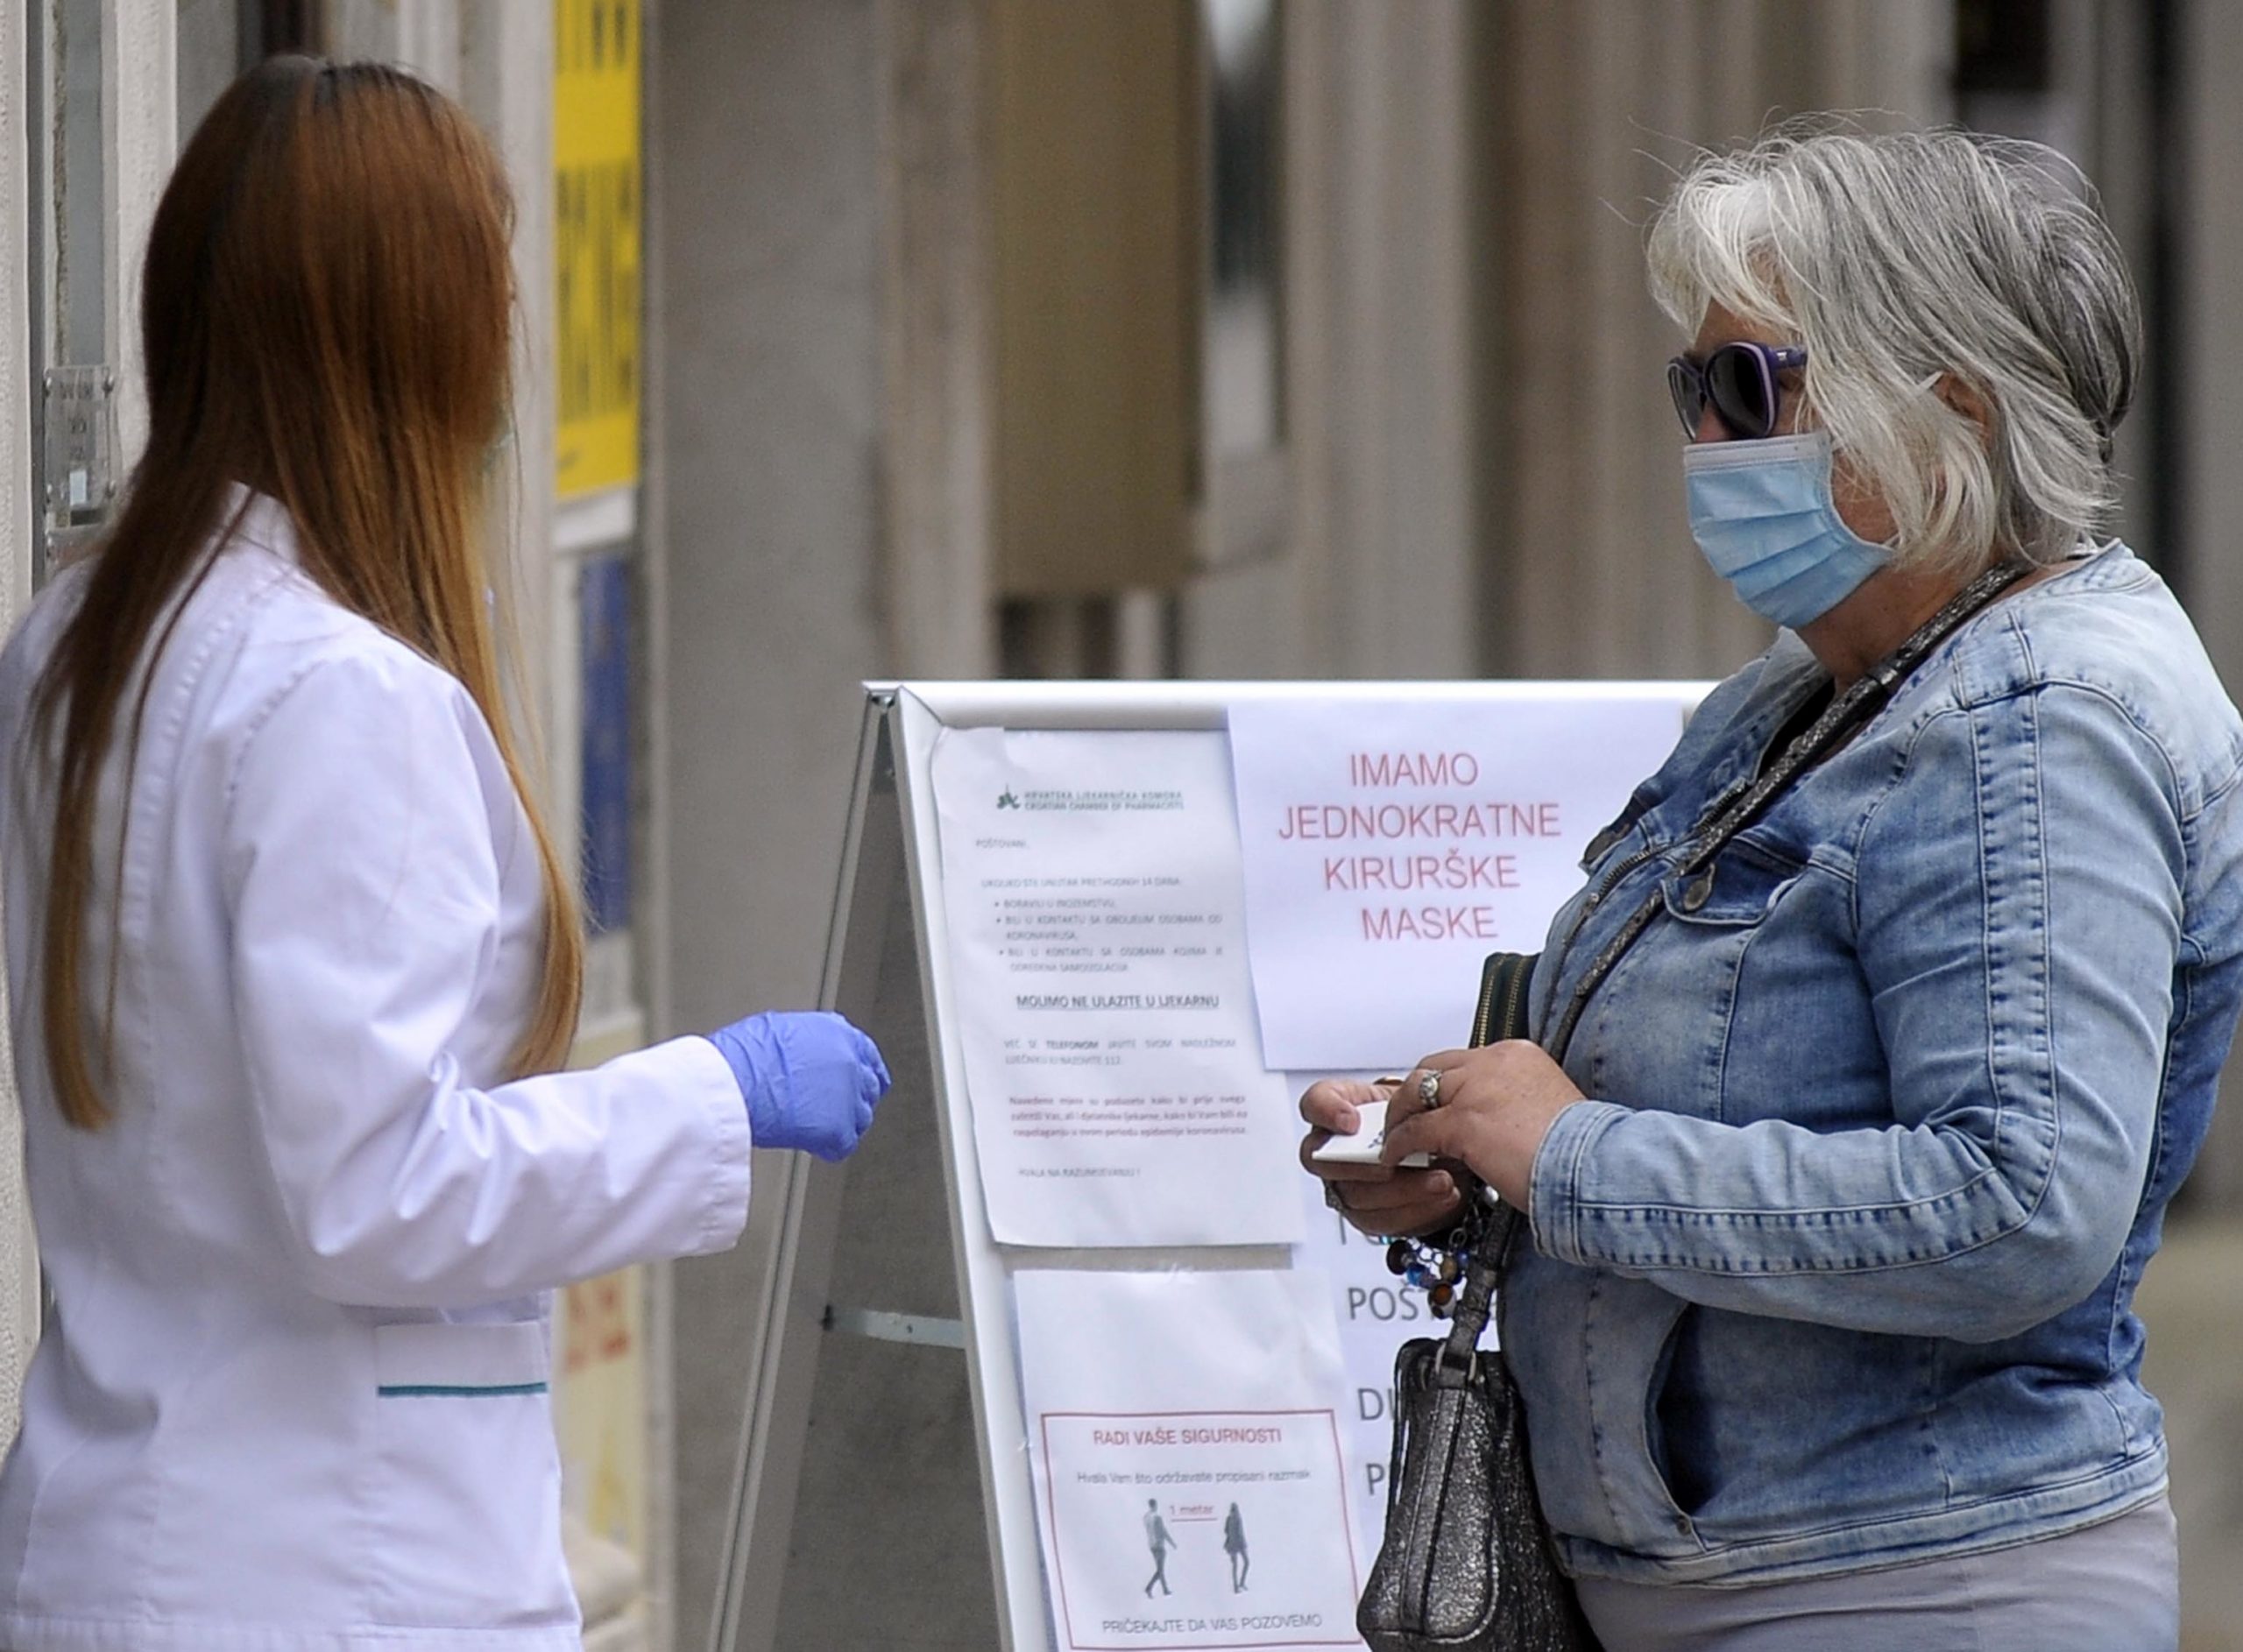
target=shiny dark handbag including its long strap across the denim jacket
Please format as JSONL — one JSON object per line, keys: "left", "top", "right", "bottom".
{"left": 1355, "top": 562, "right": 2027, "bottom": 1652}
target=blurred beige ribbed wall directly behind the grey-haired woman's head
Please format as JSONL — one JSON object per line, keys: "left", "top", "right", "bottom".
{"left": 1180, "top": 0, "right": 1951, "bottom": 677}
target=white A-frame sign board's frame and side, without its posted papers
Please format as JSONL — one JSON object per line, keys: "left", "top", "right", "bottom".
{"left": 713, "top": 681, "right": 1705, "bottom": 1652}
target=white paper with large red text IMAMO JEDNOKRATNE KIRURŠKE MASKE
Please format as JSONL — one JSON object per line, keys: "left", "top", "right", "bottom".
{"left": 1229, "top": 690, "right": 1682, "bottom": 1071}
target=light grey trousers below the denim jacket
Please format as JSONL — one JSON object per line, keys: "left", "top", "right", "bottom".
{"left": 1579, "top": 1493, "right": 2180, "bottom": 1652}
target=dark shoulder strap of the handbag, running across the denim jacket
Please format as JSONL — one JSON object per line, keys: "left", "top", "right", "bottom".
{"left": 1433, "top": 561, "right": 2032, "bottom": 1362}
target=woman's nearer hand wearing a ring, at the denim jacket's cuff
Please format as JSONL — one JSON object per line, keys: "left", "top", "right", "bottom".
{"left": 1372, "top": 1038, "right": 1581, "bottom": 1212}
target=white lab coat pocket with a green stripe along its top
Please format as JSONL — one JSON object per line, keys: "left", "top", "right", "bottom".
{"left": 370, "top": 1320, "right": 574, "bottom": 1629}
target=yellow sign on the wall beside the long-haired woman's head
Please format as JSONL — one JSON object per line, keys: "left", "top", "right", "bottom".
{"left": 554, "top": 0, "right": 644, "bottom": 500}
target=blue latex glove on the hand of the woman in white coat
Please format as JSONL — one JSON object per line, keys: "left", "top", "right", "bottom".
{"left": 709, "top": 1009, "right": 888, "bottom": 1159}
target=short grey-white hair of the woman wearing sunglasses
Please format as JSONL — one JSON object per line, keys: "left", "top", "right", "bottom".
{"left": 1649, "top": 125, "right": 2142, "bottom": 576}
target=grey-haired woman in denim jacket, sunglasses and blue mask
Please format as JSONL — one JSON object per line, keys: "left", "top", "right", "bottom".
{"left": 1301, "top": 130, "right": 2243, "bottom": 1652}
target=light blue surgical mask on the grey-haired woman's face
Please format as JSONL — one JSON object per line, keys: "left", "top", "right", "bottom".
{"left": 1682, "top": 430, "right": 1893, "bottom": 628}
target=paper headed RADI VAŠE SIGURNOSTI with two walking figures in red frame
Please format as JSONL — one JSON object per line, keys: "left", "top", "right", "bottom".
{"left": 1014, "top": 1271, "right": 1363, "bottom": 1652}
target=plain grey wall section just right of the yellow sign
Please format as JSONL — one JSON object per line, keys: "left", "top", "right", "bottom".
{"left": 648, "top": 0, "right": 890, "bottom": 1648}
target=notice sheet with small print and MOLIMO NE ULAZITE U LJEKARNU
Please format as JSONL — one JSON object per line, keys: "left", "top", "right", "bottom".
{"left": 933, "top": 729, "right": 1301, "bottom": 1246}
